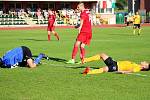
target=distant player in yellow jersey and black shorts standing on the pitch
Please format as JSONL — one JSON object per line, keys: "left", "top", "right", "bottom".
{"left": 133, "top": 12, "right": 141, "bottom": 35}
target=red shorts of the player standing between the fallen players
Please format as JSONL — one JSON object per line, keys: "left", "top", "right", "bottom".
{"left": 77, "top": 33, "right": 92, "bottom": 45}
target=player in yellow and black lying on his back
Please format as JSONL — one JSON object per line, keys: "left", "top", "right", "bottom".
{"left": 83, "top": 53, "right": 150, "bottom": 74}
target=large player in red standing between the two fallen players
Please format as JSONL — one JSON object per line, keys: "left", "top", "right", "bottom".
{"left": 66, "top": 3, "right": 92, "bottom": 64}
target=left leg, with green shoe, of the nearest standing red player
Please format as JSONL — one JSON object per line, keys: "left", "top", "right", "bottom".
{"left": 67, "top": 41, "right": 81, "bottom": 64}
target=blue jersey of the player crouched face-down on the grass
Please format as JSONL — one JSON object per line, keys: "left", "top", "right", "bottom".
{"left": 2, "top": 47, "right": 23, "bottom": 68}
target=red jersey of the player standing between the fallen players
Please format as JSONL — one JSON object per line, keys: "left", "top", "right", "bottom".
{"left": 80, "top": 10, "right": 92, "bottom": 33}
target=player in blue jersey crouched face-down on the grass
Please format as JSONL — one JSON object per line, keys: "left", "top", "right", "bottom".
{"left": 0, "top": 46, "right": 46, "bottom": 68}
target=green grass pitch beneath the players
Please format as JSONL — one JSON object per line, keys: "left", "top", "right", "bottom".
{"left": 0, "top": 27, "right": 150, "bottom": 100}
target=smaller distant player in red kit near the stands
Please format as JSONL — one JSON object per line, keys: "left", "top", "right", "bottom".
{"left": 47, "top": 9, "right": 59, "bottom": 41}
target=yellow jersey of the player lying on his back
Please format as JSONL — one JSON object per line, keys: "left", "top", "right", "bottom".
{"left": 117, "top": 61, "right": 141, "bottom": 72}
